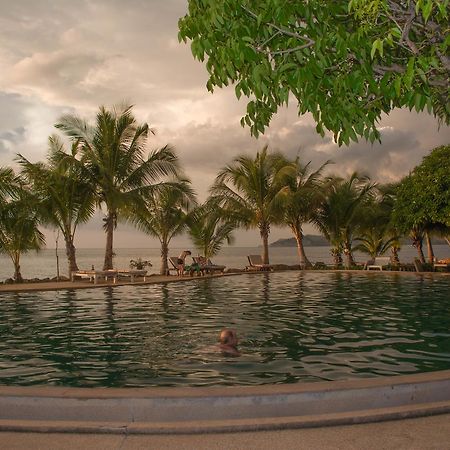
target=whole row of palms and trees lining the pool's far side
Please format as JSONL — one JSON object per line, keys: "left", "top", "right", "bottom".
{"left": 0, "top": 106, "right": 450, "bottom": 282}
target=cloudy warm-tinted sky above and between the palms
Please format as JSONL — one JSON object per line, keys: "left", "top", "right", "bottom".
{"left": 0, "top": 0, "right": 450, "bottom": 248}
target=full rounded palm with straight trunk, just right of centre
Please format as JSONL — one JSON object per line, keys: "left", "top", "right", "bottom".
{"left": 211, "top": 146, "right": 295, "bottom": 264}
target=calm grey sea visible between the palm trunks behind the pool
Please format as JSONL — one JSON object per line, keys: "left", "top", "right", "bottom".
{"left": 0, "top": 245, "right": 450, "bottom": 281}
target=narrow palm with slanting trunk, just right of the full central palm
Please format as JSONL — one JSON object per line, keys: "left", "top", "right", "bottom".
{"left": 283, "top": 157, "right": 330, "bottom": 269}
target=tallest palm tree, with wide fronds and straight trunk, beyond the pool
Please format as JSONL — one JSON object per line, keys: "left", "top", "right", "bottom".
{"left": 56, "top": 106, "right": 178, "bottom": 270}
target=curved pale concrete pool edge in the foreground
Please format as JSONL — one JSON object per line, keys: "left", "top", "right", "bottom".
{"left": 0, "top": 370, "right": 450, "bottom": 434}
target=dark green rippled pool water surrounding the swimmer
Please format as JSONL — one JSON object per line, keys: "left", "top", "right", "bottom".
{"left": 0, "top": 272, "right": 450, "bottom": 387}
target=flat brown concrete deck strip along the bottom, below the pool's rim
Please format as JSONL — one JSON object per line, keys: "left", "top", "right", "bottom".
{"left": 0, "top": 414, "right": 450, "bottom": 450}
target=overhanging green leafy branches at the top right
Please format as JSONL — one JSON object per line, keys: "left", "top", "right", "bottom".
{"left": 179, "top": 0, "right": 450, "bottom": 145}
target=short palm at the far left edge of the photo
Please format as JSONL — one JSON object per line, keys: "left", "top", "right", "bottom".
{"left": 0, "top": 182, "right": 45, "bottom": 283}
